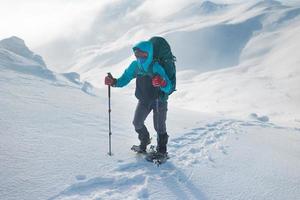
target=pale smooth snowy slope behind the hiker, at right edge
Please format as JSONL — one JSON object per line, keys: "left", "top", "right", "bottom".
{"left": 174, "top": 1, "right": 300, "bottom": 126}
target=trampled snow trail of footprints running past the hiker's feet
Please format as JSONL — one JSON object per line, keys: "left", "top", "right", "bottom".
{"left": 49, "top": 119, "right": 300, "bottom": 200}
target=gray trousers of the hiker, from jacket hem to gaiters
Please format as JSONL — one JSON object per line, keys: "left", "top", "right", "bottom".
{"left": 133, "top": 100, "right": 168, "bottom": 135}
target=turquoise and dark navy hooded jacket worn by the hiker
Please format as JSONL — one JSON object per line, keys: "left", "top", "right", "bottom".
{"left": 115, "top": 41, "right": 172, "bottom": 102}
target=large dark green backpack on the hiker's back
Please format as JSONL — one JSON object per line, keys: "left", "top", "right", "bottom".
{"left": 149, "top": 36, "right": 176, "bottom": 94}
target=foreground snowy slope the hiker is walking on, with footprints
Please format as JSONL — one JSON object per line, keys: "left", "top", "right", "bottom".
{"left": 0, "top": 35, "right": 300, "bottom": 200}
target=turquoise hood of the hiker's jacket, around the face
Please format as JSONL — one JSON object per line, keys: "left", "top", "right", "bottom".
{"left": 132, "top": 41, "right": 153, "bottom": 72}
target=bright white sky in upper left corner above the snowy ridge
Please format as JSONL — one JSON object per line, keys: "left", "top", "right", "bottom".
{"left": 0, "top": 0, "right": 109, "bottom": 48}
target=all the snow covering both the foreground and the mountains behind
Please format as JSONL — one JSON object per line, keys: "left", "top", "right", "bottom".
{"left": 0, "top": 0, "right": 300, "bottom": 200}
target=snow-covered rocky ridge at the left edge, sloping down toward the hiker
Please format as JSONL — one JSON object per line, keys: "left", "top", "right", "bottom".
{"left": 0, "top": 36, "right": 93, "bottom": 95}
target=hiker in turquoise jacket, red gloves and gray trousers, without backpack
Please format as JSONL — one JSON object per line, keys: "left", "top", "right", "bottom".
{"left": 105, "top": 41, "right": 173, "bottom": 154}
